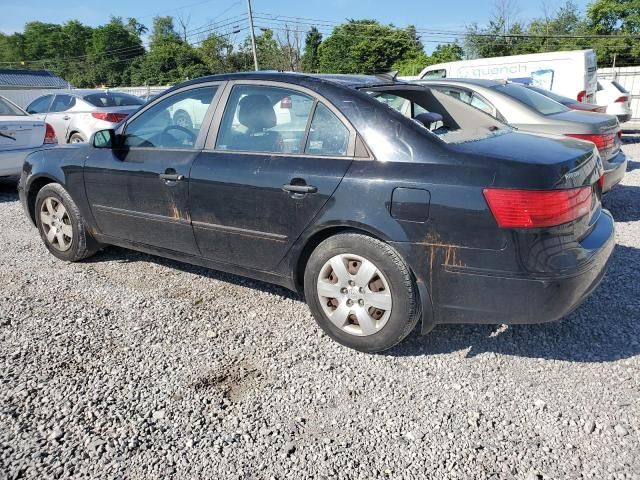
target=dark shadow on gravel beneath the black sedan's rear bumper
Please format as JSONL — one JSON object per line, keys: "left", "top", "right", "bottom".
{"left": 384, "top": 245, "right": 640, "bottom": 362}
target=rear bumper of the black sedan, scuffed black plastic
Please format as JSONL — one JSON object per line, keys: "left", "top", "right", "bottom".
{"left": 390, "top": 210, "right": 615, "bottom": 332}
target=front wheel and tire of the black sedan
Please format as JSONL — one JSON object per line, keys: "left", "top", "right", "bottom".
{"left": 35, "top": 183, "right": 100, "bottom": 262}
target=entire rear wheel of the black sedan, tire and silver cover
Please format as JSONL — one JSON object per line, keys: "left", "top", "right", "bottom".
{"left": 304, "top": 233, "right": 420, "bottom": 353}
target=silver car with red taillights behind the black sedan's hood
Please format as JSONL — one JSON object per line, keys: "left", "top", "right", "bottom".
{"left": 26, "top": 90, "right": 145, "bottom": 143}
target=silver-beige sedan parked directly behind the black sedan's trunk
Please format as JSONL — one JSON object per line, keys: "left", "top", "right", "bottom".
{"left": 414, "top": 78, "right": 627, "bottom": 192}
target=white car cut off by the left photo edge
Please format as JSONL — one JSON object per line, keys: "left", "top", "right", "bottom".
{"left": 0, "top": 97, "right": 58, "bottom": 177}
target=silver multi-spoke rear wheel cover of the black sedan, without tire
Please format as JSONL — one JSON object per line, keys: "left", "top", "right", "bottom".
{"left": 317, "top": 253, "right": 393, "bottom": 336}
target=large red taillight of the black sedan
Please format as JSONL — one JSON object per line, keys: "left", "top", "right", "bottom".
{"left": 483, "top": 187, "right": 592, "bottom": 228}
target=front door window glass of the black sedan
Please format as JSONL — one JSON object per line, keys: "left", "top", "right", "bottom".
{"left": 124, "top": 86, "right": 218, "bottom": 148}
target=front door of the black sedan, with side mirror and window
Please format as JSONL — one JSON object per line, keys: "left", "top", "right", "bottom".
{"left": 84, "top": 84, "right": 218, "bottom": 254}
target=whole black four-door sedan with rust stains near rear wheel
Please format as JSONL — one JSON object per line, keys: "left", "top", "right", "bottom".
{"left": 19, "top": 72, "right": 614, "bottom": 352}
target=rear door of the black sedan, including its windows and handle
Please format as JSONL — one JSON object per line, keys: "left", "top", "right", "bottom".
{"left": 190, "top": 82, "right": 355, "bottom": 271}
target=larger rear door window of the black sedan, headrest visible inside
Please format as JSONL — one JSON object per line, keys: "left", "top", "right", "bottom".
{"left": 216, "top": 85, "right": 313, "bottom": 153}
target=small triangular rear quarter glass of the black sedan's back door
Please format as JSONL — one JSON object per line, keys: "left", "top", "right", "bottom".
{"left": 304, "top": 103, "right": 349, "bottom": 157}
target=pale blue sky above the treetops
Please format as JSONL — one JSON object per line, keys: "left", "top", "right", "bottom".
{"left": 0, "top": 0, "right": 587, "bottom": 51}
